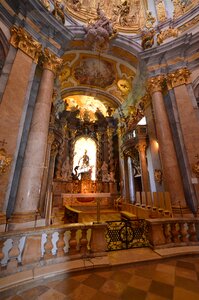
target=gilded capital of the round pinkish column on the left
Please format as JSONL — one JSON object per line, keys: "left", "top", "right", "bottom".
{"left": 41, "top": 48, "right": 63, "bottom": 75}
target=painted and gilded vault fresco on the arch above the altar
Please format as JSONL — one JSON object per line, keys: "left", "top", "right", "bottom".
{"left": 59, "top": 51, "right": 136, "bottom": 103}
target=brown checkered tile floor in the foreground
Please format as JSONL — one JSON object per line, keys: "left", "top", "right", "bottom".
{"left": 0, "top": 255, "right": 199, "bottom": 300}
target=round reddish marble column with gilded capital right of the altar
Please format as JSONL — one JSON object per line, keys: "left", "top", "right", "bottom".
{"left": 147, "top": 75, "right": 186, "bottom": 206}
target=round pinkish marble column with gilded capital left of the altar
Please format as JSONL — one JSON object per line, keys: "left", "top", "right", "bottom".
{"left": 12, "top": 49, "right": 62, "bottom": 223}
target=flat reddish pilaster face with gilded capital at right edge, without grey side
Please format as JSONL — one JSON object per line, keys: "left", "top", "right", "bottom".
{"left": 167, "top": 68, "right": 199, "bottom": 202}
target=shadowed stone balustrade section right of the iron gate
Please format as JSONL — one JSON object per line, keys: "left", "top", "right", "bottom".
{"left": 147, "top": 218, "right": 199, "bottom": 248}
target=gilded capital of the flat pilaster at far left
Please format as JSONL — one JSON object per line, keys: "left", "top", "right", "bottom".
{"left": 10, "top": 26, "right": 42, "bottom": 63}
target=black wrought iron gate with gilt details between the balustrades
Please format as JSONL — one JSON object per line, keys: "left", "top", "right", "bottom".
{"left": 106, "top": 219, "right": 149, "bottom": 251}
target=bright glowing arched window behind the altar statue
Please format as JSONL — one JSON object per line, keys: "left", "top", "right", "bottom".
{"left": 73, "top": 137, "right": 97, "bottom": 180}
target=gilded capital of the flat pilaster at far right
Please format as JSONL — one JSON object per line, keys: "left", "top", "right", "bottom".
{"left": 167, "top": 68, "right": 191, "bottom": 90}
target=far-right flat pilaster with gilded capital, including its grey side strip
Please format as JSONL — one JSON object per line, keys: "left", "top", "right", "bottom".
{"left": 167, "top": 68, "right": 199, "bottom": 214}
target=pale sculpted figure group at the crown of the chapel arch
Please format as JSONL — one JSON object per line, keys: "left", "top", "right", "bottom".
{"left": 84, "top": 5, "right": 116, "bottom": 51}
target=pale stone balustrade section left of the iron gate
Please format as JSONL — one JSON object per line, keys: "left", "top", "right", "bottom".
{"left": 0, "top": 223, "right": 107, "bottom": 277}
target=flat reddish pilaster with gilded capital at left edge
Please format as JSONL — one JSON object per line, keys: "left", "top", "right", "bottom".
{"left": 0, "top": 26, "right": 41, "bottom": 227}
